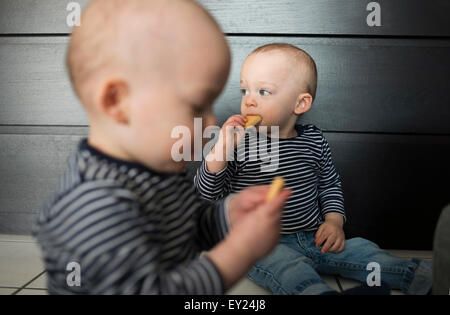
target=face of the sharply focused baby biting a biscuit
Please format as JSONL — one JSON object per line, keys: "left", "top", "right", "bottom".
{"left": 241, "top": 50, "right": 300, "bottom": 129}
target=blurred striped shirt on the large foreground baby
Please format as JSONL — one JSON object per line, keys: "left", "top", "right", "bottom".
{"left": 33, "top": 139, "right": 228, "bottom": 294}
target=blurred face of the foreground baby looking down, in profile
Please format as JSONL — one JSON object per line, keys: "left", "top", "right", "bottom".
{"left": 121, "top": 34, "right": 230, "bottom": 173}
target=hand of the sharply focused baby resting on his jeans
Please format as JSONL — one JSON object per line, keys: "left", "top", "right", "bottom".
{"left": 315, "top": 213, "right": 345, "bottom": 254}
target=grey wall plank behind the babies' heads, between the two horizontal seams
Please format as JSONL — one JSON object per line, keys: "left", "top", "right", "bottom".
{"left": 0, "top": 36, "right": 450, "bottom": 134}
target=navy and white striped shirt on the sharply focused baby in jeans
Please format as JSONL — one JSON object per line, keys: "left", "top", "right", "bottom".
{"left": 194, "top": 125, "right": 345, "bottom": 234}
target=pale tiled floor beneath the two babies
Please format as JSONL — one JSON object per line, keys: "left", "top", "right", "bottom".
{"left": 0, "top": 234, "right": 432, "bottom": 295}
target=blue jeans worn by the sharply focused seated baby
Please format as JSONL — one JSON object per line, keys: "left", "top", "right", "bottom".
{"left": 248, "top": 231, "right": 432, "bottom": 294}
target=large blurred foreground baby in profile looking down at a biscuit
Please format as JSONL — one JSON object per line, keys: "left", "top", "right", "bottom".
{"left": 33, "top": 0, "right": 290, "bottom": 294}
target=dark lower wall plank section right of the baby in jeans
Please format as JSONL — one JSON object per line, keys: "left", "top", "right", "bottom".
{"left": 325, "top": 133, "right": 450, "bottom": 250}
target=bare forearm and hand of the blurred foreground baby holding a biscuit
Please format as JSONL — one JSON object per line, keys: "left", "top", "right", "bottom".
{"left": 198, "top": 183, "right": 290, "bottom": 289}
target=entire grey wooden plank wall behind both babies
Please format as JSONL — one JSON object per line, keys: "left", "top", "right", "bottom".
{"left": 0, "top": 0, "right": 450, "bottom": 249}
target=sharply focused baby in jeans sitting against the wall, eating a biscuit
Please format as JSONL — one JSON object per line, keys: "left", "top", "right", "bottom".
{"left": 194, "top": 43, "right": 431, "bottom": 294}
